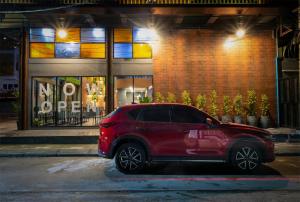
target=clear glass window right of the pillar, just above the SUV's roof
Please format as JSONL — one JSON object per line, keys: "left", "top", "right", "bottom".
{"left": 114, "top": 76, "right": 153, "bottom": 108}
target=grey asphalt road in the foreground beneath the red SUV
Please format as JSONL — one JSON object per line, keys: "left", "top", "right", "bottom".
{"left": 0, "top": 157, "right": 300, "bottom": 202}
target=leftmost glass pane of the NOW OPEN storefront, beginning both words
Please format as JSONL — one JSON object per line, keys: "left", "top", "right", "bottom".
{"left": 32, "top": 77, "right": 56, "bottom": 127}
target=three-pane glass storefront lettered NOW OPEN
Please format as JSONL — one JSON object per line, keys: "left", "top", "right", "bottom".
{"left": 32, "top": 77, "right": 106, "bottom": 127}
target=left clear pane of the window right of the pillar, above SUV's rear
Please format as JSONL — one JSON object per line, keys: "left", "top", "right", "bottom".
{"left": 114, "top": 76, "right": 133, "bottom": 108}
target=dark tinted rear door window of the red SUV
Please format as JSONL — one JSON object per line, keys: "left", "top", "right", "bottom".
{"left": 138, "top": 106, "right": 170, "bottom": 122}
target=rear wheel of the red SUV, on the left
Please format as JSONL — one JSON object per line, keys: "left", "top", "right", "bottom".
{"left": 115, "top": 143, "right": 146, "bottom": 174}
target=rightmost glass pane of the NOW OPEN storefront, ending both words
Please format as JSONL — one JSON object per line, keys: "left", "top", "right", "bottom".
{"left": 82, "top": 77, "right": 105, "bottom": 126}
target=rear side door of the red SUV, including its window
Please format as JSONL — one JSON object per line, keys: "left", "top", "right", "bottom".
{"left": 138, "top": 105, "right": 185, "bottom": 157}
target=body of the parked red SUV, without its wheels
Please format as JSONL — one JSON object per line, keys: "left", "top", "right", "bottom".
{"left": 98, "top": 104, "right": 275, "bottom": 172}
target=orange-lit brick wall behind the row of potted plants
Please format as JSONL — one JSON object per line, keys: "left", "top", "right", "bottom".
{"left": 153, "top": 29, "right": 276, "bottom": 118}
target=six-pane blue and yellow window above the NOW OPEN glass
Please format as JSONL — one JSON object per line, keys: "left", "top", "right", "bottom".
{"left": 30, "top": 28, "right": 106, "bottom": 59}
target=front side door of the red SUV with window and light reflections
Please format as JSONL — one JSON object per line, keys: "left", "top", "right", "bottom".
{"left": 171, "top": 106, "right": 225, "bottom": 159}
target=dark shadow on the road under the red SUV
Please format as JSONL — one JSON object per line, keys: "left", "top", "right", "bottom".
{"left": 141, "top": 162, "right": 281, "bottom": 176}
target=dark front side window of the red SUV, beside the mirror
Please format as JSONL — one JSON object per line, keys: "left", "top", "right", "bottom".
{"left": 171, "top": 106, "right": 206, "bottom": 123}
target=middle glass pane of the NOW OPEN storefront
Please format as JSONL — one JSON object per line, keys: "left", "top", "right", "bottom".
{"left": 56, "top": 77, "right": 81, "bottom": 126}
